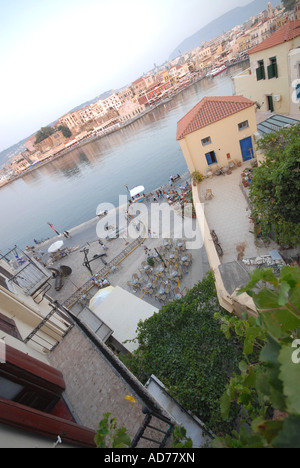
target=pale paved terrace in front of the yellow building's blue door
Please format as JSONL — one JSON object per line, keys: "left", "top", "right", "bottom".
{"left": 200, "top": 163, "right": 278, "bottom": 263}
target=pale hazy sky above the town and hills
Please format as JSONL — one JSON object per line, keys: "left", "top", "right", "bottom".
{"left": 0, "top": 0, "right": 251, "bottom": 151}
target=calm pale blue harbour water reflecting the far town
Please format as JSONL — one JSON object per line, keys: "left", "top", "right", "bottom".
{"left": 0, "top": 66, "right": 246, "bottom": 253}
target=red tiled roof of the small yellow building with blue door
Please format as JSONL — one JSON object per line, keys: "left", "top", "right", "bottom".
{"left": 176, "top": 96, "right": 255, "bottom": 140}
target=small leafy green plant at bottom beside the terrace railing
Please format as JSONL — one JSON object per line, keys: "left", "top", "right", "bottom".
{"left": 95, "top": 413, "right": 131, "bottom": 448}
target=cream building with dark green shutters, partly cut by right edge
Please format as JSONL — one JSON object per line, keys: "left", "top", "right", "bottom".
{"left": 234, "top": 20, "right": 300, "bottom": 114}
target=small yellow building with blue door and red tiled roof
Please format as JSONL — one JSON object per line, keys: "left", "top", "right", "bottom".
{"left": 177, "top": 96, "right": 257, "bottom": 175}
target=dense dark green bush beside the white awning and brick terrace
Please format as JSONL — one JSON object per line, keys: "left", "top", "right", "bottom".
{"left": 122, "top": 273, "right": 242, "bottom": 434}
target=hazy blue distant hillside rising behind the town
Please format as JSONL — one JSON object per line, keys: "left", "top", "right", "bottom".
{"left": 169, "top": 0, "right": 280, "bottom": 60}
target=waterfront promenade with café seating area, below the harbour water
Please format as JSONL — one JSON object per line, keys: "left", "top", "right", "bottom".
{"left": 30, "top": 174, "right": 209, "bottom": 308}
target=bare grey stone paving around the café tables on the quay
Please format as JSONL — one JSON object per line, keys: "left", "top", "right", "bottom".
{"left": 32, "top": 174, "right": 210, "bottom": 308}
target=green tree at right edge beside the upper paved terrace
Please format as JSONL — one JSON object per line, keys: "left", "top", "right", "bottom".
{"left": 250, "top": 124, "right": 300, "bottom": 246}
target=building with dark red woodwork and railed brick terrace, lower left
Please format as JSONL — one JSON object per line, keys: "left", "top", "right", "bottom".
{"left": 0, "top": 248, "right": 175, "bottom": 448}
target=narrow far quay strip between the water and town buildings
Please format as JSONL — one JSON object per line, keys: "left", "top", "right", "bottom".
{"left": 0, "top": 59, "right": 248, "bottom": 190}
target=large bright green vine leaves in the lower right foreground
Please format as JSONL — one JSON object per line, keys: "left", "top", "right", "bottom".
{"left": 214, "top": 267, "right": 300, "bottom": 448}
